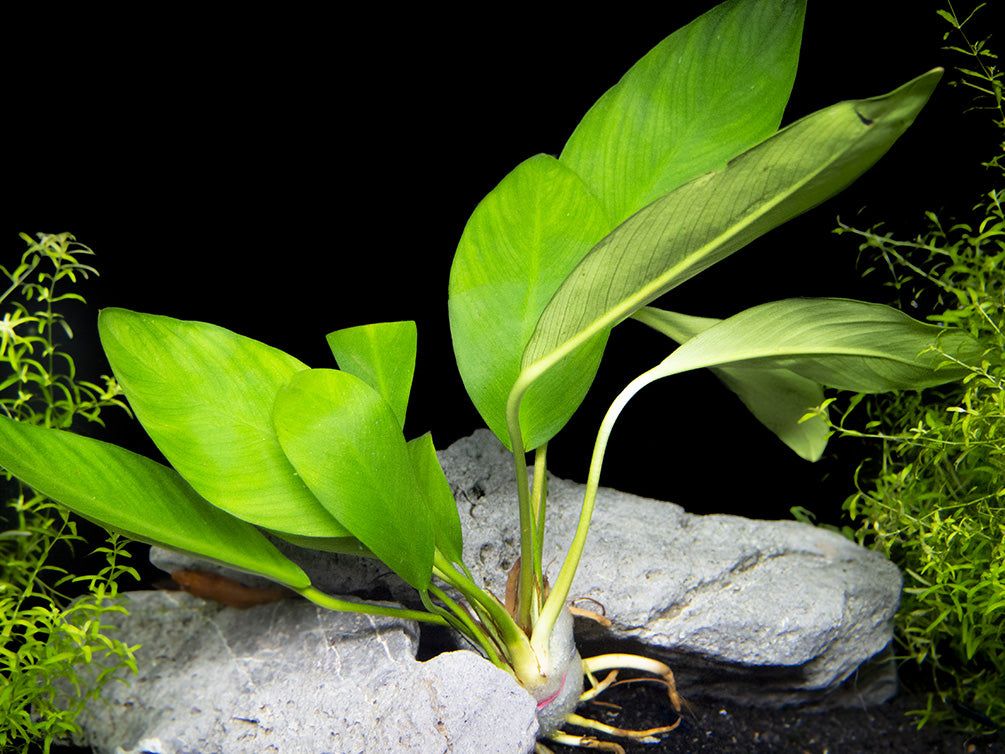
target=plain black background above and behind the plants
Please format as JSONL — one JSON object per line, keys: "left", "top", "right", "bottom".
{"left": 7, "top": 0, "right": 992, "bottom": 538}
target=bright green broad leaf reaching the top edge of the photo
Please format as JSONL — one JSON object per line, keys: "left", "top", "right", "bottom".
{"left": 559, "top": 0, "right": 806, "bottom": 226}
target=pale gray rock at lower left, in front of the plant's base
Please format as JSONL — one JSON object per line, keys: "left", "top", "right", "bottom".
{"left": 72, "top": 592, "right": 538, "bottom": 754}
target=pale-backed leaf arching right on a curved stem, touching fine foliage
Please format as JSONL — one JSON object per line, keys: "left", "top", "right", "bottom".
{"left": 648, "top": 299, "right": 980, "bottom": 393}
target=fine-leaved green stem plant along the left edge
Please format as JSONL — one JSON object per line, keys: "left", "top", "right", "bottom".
{"left": 0, "top": 233, "right": 136, "bottom": 752}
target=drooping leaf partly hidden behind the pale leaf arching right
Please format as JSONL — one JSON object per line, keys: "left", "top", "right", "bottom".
{"left": 633, "top": 307, "right": 830, "bottom": 460}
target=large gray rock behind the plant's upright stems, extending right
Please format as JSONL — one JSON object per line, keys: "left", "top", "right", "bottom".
{"left": 440, "top": 430, "right": 901, "bottom": 707}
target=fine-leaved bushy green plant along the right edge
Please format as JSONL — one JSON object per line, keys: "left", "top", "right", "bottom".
{"left": 838, "top": 7, "right": 1005, "bottom": 731}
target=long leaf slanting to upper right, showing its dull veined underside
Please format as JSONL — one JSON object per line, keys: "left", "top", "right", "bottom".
{"left": 515, "top": 69, "right": 942, "bottom": 392}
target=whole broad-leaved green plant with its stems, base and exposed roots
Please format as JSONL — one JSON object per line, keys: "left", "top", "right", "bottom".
{"left": 0, "top": 0, "right": 988, "bottom": 751}
